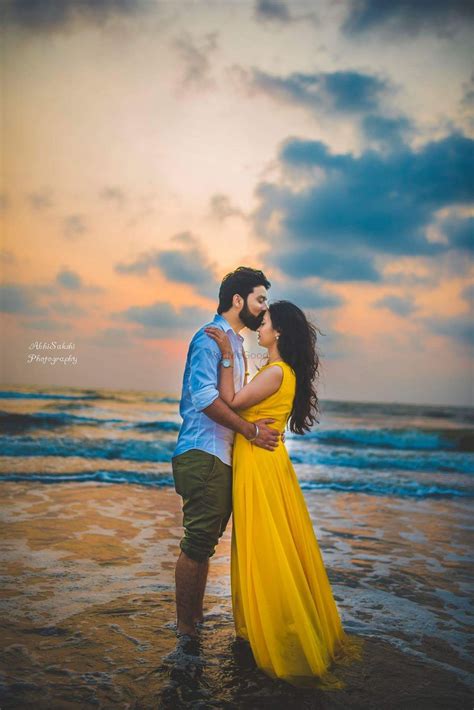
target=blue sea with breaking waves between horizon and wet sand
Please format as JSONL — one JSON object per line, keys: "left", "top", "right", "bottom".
{"left": 0, "top": 387, "right": 474, "bottom": 498}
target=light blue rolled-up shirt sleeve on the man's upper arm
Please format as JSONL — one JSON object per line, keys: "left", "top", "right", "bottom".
{"left": 189, "top": 334, "right": 221, "bottom": 412}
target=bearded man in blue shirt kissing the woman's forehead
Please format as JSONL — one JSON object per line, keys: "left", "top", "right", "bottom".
{"left": 172, "top": 266, "right": 280, "bottom": 636}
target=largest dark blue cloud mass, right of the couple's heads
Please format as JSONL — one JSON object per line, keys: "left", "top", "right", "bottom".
{"left": 254, "top": 134, "right": 474, "bottom": 281}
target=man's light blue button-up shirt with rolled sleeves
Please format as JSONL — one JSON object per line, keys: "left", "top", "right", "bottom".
{"left": 173, "top": 314, "right": 245, "bottom": 465}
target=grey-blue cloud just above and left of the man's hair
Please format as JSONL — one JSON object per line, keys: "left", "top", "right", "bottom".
{"left": 115, "top": 232, "right": 219, "bottom": 298}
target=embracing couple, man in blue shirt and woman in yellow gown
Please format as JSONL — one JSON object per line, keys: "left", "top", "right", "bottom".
{"left": 172, "top": 267, "right": 345, "bottom": 686}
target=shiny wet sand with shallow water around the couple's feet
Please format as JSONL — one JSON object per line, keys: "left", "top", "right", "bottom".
{"left": 0, "top": 483, "right": 472, "bottom": 710}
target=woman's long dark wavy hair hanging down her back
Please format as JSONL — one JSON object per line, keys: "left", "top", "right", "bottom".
{"left": 268, "top": 301, "right": 321, "bottom": 434}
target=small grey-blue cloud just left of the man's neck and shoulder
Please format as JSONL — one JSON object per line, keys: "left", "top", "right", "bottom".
{"left": 113, "top": 301, "right": 212, "bottom": 338}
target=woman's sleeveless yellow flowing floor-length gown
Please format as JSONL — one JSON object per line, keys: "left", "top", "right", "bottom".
{"left": 231, "top": 361, "right": 345, "bottom": 687}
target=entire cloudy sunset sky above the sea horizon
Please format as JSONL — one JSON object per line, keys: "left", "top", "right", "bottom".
{"left": 0, "top": 0, "right": 474, "bottom": 405}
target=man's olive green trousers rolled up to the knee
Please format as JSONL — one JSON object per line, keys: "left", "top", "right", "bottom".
{"left": 171, "top": 449, "right": 232, "bottom": 562}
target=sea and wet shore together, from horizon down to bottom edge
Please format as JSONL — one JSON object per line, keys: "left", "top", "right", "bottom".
{"left": 0, "top": 387, "right": 474, "bottom": 710}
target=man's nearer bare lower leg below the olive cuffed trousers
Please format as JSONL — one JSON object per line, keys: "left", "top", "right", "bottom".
{"left": 175, "top": 551, "right": 205, "bottom": 636}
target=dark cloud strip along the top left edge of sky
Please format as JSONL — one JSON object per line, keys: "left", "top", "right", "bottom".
{"left": 2, "top": 0, "right": 152, "bottom": 32}
